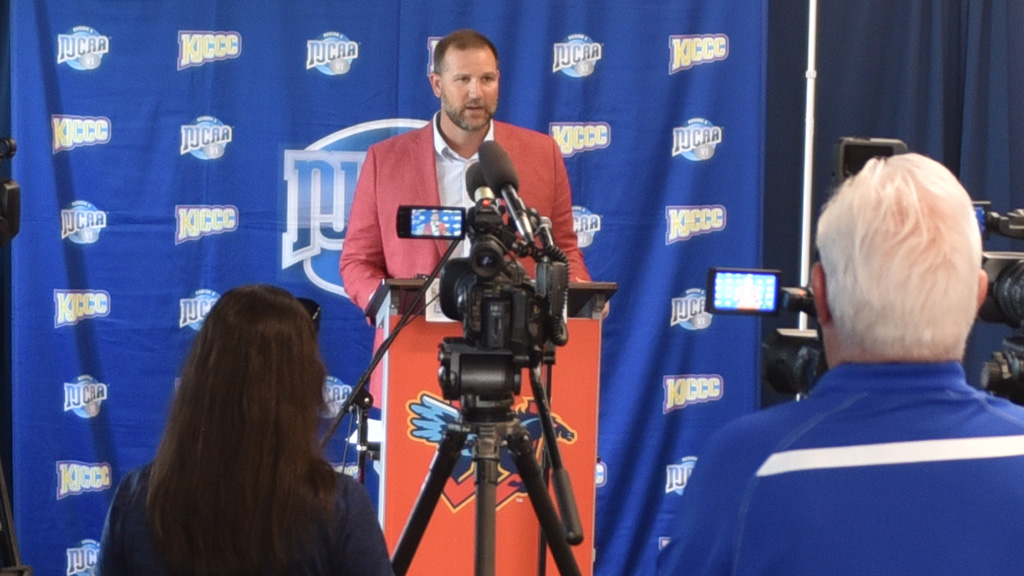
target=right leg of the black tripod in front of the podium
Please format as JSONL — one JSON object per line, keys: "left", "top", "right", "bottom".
{"left": 506, "top": 425, "right": 581, "bottom": 576}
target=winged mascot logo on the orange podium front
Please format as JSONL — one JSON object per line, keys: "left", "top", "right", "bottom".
{"left": 406, "top": 392, "right": 577, "bottom": 511}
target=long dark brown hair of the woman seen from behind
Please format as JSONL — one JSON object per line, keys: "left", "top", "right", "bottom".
{"left": 146, "top": 285, "right": 336, "bottom": 575}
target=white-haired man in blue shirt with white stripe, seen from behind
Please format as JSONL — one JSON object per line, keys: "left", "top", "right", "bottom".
{"left": 659, "top": 154, "right": 1024, "bottom": 576}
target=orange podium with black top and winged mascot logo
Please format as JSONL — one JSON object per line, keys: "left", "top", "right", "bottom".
{"left": 368, "top": 280, "right": 616, "bottom": 576}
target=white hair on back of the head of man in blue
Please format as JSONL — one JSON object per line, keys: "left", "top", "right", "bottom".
{"left": 817, "top": 154, "right": 981, "bottom": 362}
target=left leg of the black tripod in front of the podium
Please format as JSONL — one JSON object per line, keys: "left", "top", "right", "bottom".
{"left": 391, "top": 424, "right": 468, "bottom": 576}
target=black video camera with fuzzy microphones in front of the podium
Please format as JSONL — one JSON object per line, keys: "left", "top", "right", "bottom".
{"left": 398, "top": 141, "right": 568, "bottom": 404}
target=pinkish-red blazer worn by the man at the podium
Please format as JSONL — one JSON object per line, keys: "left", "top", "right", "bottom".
{"left": 341, "top": 121, "right": 590, "bottom": 311}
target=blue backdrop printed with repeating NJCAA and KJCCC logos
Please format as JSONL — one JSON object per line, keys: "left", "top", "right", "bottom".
{"left": 11, "top": 0, "right": 766, "bottom": 575}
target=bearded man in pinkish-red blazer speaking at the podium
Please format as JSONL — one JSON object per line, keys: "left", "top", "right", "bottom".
{"left": 341, "top": 30, "right": 590, "bottom": 311}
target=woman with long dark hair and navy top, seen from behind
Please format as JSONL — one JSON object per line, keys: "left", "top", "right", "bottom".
{"left": 97, "top": 285, "right": 392, "bottom": 576}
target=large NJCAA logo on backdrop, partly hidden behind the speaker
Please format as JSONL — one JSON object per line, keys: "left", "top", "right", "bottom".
{"left": 281, "top": 119, "right": 426, "bottom": 296}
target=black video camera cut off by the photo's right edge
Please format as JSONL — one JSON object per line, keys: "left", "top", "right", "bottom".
{"left": 974, "top": 202, "right": 1024, "bottom": 405}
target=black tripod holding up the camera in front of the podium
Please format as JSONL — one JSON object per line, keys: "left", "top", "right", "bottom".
{"left": 391, "top": 364, "right": 583, "bottom": 576}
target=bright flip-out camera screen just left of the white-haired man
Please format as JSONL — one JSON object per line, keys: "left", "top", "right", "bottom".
{"left": 707, "top": 269, "right": 780, "bottom": 315}
